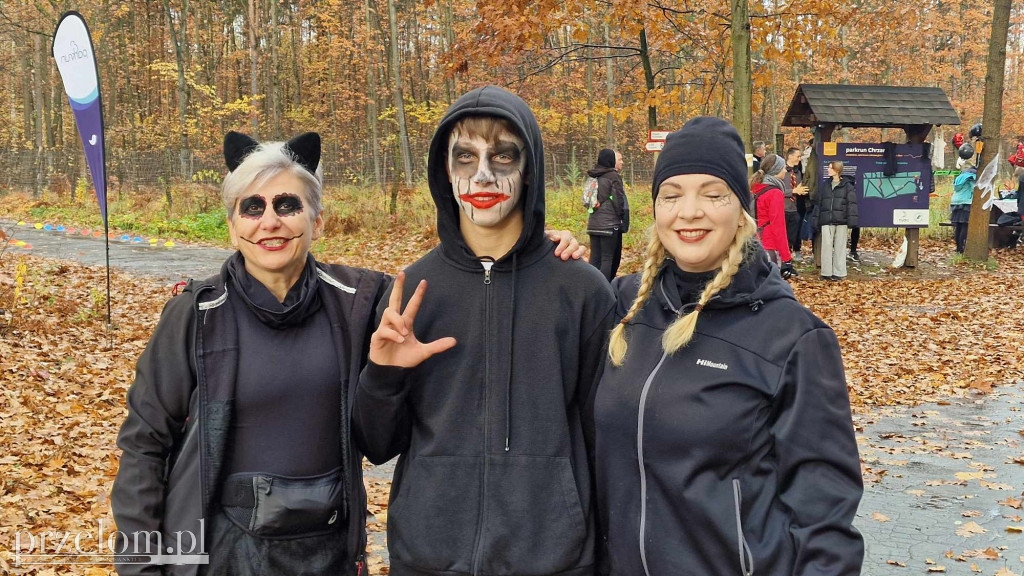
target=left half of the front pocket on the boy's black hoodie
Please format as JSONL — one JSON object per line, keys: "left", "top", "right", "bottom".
{"left": 387, "top": 456, "right": 483, "bottom": 572}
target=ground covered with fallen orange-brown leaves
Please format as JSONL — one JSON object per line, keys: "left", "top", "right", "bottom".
{"left": 0, "top": 235, "right": 1024, "bottom": 576}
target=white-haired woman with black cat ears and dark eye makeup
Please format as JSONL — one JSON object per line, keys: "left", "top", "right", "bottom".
{"left": 111, "top": 132, "right": 583, "bottom": 576}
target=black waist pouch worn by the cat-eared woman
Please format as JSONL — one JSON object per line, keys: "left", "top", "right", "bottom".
{"left": 220, "top": 467, "right": 346, "bottom": 538}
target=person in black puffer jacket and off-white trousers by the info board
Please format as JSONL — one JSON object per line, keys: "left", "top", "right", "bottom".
{"left": 814, "top": 160, "right": 858, "bottom": 282}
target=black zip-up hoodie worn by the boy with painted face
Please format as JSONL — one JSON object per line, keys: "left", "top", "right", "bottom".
{"left": 352, "top": 86, "right": 614, "bottom": 576}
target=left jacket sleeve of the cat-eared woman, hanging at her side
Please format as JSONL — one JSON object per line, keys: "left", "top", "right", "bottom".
{"left": 111, "top": 293, "right": 197, "bottom": 576}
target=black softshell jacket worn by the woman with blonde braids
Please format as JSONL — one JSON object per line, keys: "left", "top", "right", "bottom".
{"left": 595, "top": 248, "right": 863, "bottom": 576}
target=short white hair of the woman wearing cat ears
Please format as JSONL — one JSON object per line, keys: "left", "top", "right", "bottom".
{"left": 221, "top": 142, "right": 324, "bottom": 221}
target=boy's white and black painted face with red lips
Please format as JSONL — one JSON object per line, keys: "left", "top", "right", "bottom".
{"left": 447, "top": 122, "right": 526, "bottom": 227}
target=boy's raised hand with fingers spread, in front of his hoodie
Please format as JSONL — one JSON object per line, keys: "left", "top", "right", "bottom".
{"left": 370, "top": 272, "right": 456, "bottom": 368}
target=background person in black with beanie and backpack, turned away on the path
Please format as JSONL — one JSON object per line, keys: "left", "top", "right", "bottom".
{"left": 587, "top": 148, "right": 630, "bottom": 281}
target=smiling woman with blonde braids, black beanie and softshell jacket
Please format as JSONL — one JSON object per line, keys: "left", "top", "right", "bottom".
{"left": 595, "top": 117, "right": 864, "bottom": 576}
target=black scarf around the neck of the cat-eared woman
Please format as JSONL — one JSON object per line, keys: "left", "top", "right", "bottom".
{"left": 227, "top": 252, "right": 321, "bottom": 330}
